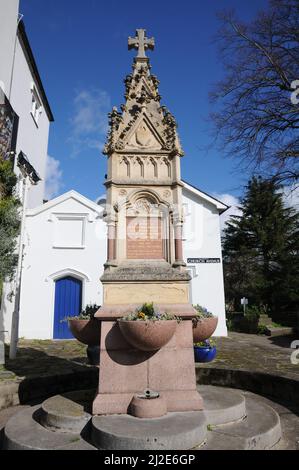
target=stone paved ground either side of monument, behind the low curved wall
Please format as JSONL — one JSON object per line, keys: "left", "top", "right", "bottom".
{"left": 0, "top": 332, "right": 299, "bottom": 384}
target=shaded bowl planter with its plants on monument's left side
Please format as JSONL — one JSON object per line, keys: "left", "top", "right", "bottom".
{"left": 65, "top": 305, "right": 101, "bottom": 346}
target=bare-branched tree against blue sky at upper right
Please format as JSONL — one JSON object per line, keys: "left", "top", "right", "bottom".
{"left": 212, "top": 0, "right": 299, "bottom": 184}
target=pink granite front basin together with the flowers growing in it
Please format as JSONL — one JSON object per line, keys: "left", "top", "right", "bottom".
{"left": 118, "top": 303, "right": 179, "bottom": 351}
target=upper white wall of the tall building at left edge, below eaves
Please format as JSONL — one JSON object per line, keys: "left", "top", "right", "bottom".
{"left": 0, "top": 0, "right": 50, "bottom": 209}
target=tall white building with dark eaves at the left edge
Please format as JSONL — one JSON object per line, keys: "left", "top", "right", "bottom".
{"left": 0, "top": 0, "right": 53, "bottom": 357}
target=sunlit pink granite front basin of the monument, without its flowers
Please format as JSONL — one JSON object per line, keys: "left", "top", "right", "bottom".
{"left": 118, "top": 319, "right": 177, "bottom": 351}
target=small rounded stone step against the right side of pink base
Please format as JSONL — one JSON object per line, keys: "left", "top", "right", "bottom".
{"left": 198, "top": 385, "right": 246, "bottom": 425}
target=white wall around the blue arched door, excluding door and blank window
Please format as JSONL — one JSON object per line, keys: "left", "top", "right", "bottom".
{"left": 5, "top": 193, "right": 106, "bottom": 339}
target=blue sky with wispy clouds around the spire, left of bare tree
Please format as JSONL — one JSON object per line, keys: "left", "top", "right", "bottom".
{"left": 20, "top": 0, "right": 267, "bottom": 207}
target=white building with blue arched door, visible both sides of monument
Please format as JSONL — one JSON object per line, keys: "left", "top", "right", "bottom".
{"left": 4, "top": 183, "right": 227, "bottom": 339}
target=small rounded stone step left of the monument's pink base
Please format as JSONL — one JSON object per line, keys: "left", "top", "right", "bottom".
{"left": 40, "top": 395, "right": 91, "bottom": 434}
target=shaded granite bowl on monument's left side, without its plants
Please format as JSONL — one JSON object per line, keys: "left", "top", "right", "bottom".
{"left": 68, "top": 318, "right": 101, "bottom": 346}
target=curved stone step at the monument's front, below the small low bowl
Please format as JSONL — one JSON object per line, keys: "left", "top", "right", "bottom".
{"left": 91, "top": 411, "right": 207, "bottom": 450}
